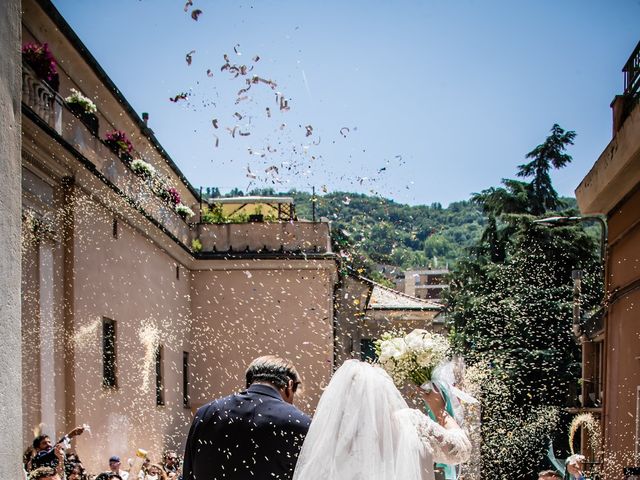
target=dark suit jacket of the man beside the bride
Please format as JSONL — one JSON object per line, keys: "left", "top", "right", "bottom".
{"left": 183, "top": 384, "right": 311, "bottom": 480}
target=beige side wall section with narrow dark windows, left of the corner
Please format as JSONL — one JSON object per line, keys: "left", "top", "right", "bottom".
{"left": 73, "top": 189, "right": 191, "bottom": 467}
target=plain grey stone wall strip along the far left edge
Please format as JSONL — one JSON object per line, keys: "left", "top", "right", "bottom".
{"left": 0, "top": 0, "right": 22, "bottom": 478}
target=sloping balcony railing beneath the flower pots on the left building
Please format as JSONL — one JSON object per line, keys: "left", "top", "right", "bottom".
{"left": 22, "top": 64, "right": 191, "bottom": 246}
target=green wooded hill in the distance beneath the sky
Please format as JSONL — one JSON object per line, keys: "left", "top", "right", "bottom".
{"left": 202, "top": 188, "right": 576, "bottom": 269}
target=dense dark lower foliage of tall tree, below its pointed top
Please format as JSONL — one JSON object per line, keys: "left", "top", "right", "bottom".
{"left": 446, "top": 220, "right": 599, "bottom": 479}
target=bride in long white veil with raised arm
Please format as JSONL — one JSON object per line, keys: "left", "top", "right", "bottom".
{"left": 293, "top": 360, "right": 471, "bottom": 480}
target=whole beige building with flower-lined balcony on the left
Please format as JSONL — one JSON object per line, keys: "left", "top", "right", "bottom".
{"left": 15, "top": 0, "right": 337, "bottom": 472}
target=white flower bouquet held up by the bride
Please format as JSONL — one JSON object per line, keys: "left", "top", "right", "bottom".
{"left": 376, "top": 329, "right": 450, "bottom": 388}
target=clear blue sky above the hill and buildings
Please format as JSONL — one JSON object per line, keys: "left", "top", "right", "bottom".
{"left": 53, "top": 0, "right": 640, "bottom": 205}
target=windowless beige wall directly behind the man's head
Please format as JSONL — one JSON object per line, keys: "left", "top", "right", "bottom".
{"left": 192, "top": 260, "right": 335, "bottom": 413}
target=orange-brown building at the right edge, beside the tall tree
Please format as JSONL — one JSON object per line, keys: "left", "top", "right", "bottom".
{"left": 576, "top": 43, "right": 640, "bottom": 479}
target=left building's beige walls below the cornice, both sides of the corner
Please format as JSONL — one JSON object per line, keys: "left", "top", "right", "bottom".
{"left": 23, "top": 173, "right": 336, "bottom": 472}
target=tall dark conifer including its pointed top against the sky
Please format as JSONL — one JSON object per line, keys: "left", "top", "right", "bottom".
{"left": 445, "top": 125, "right": 601, "bottom": 479}
